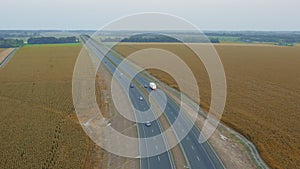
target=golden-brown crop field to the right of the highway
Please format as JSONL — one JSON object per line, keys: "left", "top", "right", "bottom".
{"left": 115, "top": 43, "right": 300, "bottom": 168}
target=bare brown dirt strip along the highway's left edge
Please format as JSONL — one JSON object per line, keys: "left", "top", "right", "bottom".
{"left": 90, "top": 53, "right": 140, "bottom": 169}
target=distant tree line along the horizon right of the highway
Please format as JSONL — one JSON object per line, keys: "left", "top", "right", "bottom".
{"left": 101, "top": 31, "right": 300, "bottom": 46}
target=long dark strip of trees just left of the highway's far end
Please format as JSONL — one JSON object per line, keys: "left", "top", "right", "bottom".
{"left": 27, "top": 36, "right": 79, "bottom": 44}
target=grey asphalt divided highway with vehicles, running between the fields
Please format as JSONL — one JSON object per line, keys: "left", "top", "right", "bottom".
{"left": 82, "top": 36, "right": 224, "bottom": 169}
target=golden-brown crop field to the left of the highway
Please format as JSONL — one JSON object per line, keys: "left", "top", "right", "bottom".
{"left": 0, "top": 45, "right": 88, "bottom": 168}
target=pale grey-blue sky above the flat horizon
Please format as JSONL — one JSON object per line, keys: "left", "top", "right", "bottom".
{"left": 0, "top": 0, "right": 300, "bottom": 31}
